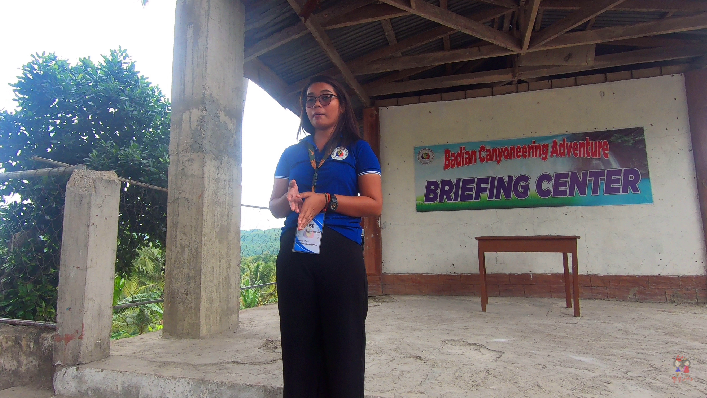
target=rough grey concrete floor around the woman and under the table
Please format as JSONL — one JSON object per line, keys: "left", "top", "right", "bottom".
{"left": 55, "top": 296, "right": 707, "bottom": 398}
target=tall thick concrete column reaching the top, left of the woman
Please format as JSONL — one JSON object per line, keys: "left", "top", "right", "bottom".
{"left": 163, "top": 0, "right": 245, "bottom": 338}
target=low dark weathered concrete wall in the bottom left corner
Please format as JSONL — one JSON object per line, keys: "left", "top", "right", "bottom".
{"left": 0, "top": 324, "right": 54, "bottom": 390}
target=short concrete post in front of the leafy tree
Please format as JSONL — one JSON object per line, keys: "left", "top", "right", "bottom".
{"left": 54, "top": 170, "right": 120, "bottom": 366}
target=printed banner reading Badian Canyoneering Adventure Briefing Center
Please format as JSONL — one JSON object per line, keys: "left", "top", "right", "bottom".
{"left": 415, "top": 127, "right": 653, "bottom": 212}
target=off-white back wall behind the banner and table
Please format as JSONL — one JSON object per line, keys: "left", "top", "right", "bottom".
{"left": 380, "top": 75, "right": 705, "bottom": 275}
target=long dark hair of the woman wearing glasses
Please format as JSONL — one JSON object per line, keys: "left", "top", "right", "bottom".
{"left": 297, "top": 75, "right": 361, "bottom": 148}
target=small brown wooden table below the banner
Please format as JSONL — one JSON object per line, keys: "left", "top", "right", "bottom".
{"left": 476, "top": 235, "right": 579, "bottom": 316}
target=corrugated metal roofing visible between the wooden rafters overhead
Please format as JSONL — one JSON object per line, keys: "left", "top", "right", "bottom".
{"left": 244, "top": 0, "right": 707, "bottom": 104}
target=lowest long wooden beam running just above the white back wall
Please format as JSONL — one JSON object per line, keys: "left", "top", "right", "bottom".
{"left": 366, "top": 47, "right": 705, "bottom": 96}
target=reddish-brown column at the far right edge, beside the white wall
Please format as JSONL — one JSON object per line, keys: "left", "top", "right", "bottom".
{"left": 685, "top": 69, "right": 707, "bottom": 266}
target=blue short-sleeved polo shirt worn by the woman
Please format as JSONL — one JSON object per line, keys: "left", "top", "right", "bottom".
{"left": 275, "top": 135, "right": 381, "bottom": 244}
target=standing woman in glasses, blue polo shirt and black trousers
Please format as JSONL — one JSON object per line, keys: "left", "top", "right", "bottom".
{"left": 270, "top": 76, "right": 383, "bottom": 398}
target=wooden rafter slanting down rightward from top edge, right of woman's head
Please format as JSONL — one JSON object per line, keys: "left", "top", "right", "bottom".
{"left": 381, "top": 0, "right": 520, "bottom": 51}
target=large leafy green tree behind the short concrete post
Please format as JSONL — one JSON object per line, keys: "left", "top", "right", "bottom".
{"left": 0, "top": 49, "right": 170, "bottom": 319}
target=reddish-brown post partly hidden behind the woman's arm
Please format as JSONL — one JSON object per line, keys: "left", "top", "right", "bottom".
{"left": 363, "top": 107, "right": 383, "bottom": 296}
